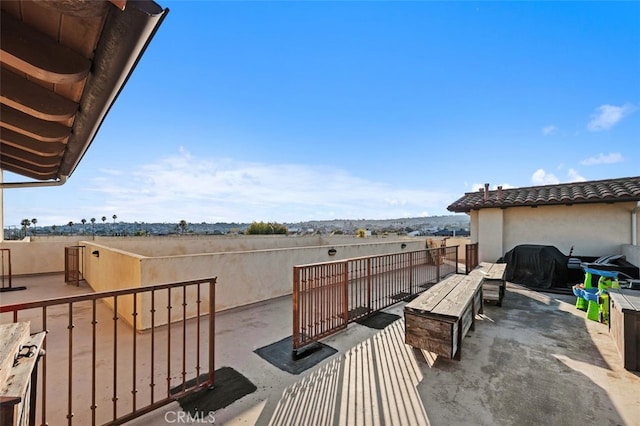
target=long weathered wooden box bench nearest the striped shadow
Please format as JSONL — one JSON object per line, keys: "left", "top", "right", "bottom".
{"left": 404, "top": 274, "right": 482, "bottom": 360}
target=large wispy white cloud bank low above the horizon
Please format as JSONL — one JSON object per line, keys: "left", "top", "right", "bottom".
{"left": 80, "top": 148, "right": 460, "bottom": 222}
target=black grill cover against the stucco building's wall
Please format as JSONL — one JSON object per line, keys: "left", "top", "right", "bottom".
{"left": 504, "top": 244, "right": 569, "bottom": 288}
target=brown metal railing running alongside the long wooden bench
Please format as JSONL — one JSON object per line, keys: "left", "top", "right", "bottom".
{"left": 293, "top": 246, "right": 458, "bottom": 353}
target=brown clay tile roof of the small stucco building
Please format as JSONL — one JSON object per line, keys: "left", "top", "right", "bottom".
{"left": 447, "top": 176, "right": 640, "bottom": 213}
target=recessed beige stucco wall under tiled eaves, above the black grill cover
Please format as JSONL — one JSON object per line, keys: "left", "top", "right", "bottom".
{"left": 504, "top": 203, "right": 635, "bottom": 256}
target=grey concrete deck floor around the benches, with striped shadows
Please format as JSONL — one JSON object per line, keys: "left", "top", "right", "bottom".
{"left": 0, "top": 276, "right": 640, "bottom": 425}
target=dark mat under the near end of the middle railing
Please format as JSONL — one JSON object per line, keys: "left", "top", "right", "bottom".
{"left": 254, "top": 336, "right": 338, "bottom": 374}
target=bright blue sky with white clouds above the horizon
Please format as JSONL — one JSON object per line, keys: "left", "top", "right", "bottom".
{"left": 4, "top": 0, "right": 640, "bottom": 226}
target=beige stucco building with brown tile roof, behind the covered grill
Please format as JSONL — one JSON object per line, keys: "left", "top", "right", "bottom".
{"left": 447, "top": 176, "right": 640, "bottom": 265}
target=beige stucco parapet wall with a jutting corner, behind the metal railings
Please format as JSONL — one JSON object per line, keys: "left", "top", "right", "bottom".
{"left": 77, "top": 239, "right": 425, "bottom": 329}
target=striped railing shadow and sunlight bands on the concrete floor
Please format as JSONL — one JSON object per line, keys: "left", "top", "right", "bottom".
{"left": 258, "top": 321, "right": 429, "bottom": 426}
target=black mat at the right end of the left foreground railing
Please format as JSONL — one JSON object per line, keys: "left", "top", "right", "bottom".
{"left": 171, "top": 367, "right": 257, "bottom": 417}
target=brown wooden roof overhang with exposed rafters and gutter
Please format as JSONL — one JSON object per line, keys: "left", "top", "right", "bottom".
{"left": 0, "top": 0, "right": 168, "bottom": 187}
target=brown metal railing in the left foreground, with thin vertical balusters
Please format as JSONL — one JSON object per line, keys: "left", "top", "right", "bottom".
{"left": 0, "top": 278, "right": 216, "bottom": 425}
